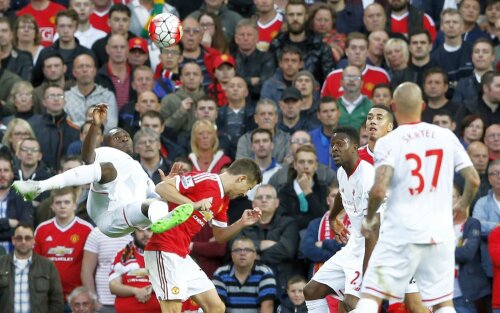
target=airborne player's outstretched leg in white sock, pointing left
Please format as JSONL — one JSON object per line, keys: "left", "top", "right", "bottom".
{"left": 12, "top": 163, "right": 107, "bottom": 201}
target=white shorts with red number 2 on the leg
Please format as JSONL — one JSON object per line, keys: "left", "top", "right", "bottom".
{"left": 312, "top": 249, "right": 363, "bottom": 301}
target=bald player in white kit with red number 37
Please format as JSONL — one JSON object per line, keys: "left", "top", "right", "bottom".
{"left": 356, "top": 83, "right": 480, "bottom": 313}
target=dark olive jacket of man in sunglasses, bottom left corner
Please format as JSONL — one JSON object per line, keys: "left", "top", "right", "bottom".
{"left": 0, "top": 253, "right": 64, "bottom": 313}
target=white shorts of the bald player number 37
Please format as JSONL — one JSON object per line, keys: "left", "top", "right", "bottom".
{"left": 361, "top": 241, "right": 455, "bottom": 307}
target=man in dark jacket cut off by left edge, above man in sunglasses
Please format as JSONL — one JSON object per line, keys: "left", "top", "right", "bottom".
{"left": 0, "top": 154, "right": 34, "bottom": 252}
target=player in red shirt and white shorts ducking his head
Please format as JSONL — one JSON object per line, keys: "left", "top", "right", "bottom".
{"left": 144, "top": 158, "right": 262, "bottom": 313}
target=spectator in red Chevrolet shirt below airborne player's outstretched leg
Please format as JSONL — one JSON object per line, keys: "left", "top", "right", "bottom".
{"left": 34, "top": 187, "right": 93, "bottom": 299}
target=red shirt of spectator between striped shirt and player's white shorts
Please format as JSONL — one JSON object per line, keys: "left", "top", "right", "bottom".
{"left": 109, "top": 243, "right": 161, "bottom": 313}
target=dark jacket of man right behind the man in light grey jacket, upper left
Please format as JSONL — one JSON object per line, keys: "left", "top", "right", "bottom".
{"left": 32, "top": 38, "right": 95, "bottom": 87}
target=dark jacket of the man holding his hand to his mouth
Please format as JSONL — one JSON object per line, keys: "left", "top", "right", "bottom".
{"left": 273, "top": 172, "right": 328, "bottom": 230}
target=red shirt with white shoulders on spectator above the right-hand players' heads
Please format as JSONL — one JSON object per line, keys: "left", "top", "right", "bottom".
{"left": 321, "top": 64, "right": 390, "bottom": 99}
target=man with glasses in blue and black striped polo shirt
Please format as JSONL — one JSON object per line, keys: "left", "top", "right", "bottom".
{"left": 213, "top": 237, "right": 277, "bottom": 313}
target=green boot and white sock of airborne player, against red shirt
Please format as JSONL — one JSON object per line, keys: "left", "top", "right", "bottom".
{"left": 148, "top": 201, "right": 194, "bottom": 234}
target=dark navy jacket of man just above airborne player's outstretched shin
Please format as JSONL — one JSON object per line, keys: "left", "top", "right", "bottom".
{"left": 31, "top": 112, "right": 80, "bottom": 170}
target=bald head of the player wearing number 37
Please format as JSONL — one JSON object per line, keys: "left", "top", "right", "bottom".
{"left": 392, "top": 82, "right": 424, "bottom": 122}
